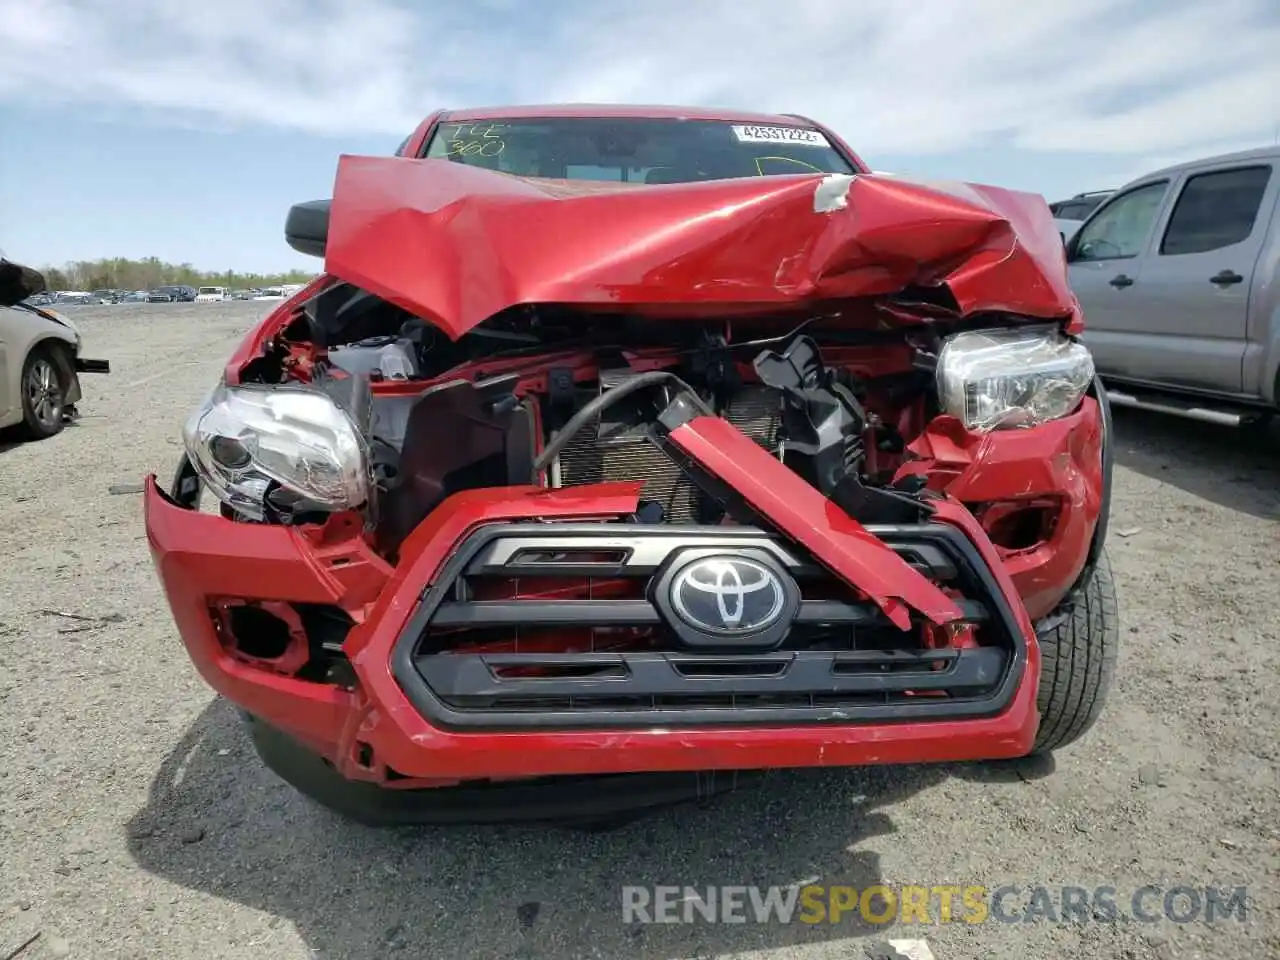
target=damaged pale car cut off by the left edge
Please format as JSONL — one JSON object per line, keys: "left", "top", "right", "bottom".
{"left": 0, "top": 260, "right": 110, "bottom": 440}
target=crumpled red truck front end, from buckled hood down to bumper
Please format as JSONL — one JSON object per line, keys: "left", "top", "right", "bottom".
{"left": 146, "top": 157, "right": 1105, "bottom": 819}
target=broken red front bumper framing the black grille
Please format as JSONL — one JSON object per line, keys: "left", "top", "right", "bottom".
{"left": 145, "top": 504, "right": 1059, "bottom": 786}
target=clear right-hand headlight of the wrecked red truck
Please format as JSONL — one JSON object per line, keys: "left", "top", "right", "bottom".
{"left": 937, "top": 328, "right": 1093, "bottom": 433}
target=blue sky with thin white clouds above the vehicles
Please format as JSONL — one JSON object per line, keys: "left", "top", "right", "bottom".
{"left": 0, "top": 0, "right": 1280, "bottom": 271}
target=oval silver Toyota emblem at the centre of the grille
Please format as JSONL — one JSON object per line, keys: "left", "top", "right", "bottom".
{"left": 671, "top": 557, "right": 787, "bottom": 636}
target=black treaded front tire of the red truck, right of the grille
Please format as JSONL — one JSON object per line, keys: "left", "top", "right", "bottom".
{"left": 1032, "top": 550, "right": 1120, "bottom": 754}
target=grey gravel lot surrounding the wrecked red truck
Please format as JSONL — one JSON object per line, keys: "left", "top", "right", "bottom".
{"left": 0, "top": 303, "right": 1280, "bottom": 960}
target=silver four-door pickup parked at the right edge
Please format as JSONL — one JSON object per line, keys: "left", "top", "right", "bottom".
{"left": 1068, "top": 146, "right": 1280, "bottom": 426}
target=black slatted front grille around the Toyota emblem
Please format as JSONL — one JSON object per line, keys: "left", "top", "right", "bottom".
{"left": 393, "top": 524, "right": 1025, "bottom": 730}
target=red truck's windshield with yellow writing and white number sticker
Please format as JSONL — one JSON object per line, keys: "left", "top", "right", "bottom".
{"left": 426, "top": 118, "right": 854, "bottom": 183}
